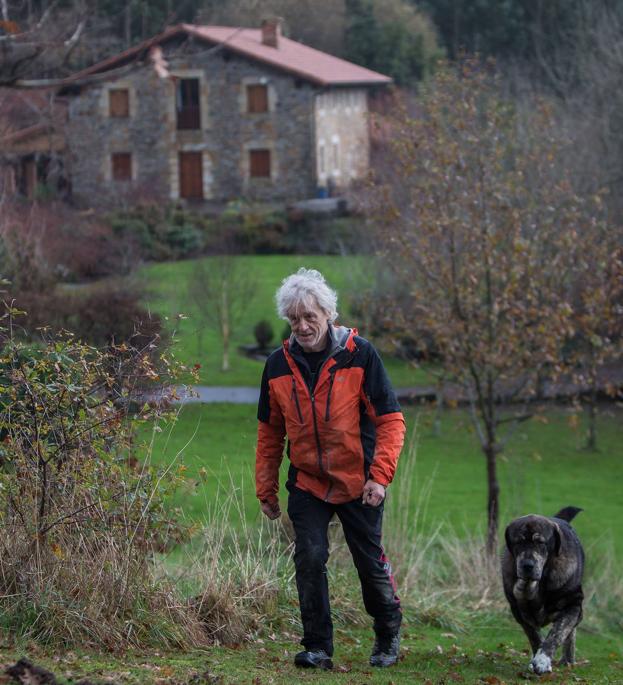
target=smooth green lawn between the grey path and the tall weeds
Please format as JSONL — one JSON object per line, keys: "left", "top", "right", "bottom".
{"left": 142, "top": 404, "right": 623, "bottom": 558}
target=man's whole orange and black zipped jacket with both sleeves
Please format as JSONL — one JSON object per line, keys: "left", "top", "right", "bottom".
{"left": 255, "top": 325, "right": 405, "bottom": 504}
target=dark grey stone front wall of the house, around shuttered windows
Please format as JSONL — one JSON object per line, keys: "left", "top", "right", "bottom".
{"left": 68, "top": 39, "right": 322, "bottom": 205}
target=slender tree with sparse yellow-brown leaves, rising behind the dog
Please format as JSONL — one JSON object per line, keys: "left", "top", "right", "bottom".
{"left": 368, "top": 61, "right": 598, "bottom": 558}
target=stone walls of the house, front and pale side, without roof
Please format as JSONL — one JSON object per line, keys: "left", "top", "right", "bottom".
{"left": 67, "top": 38, "right": 376, "bottom": 205}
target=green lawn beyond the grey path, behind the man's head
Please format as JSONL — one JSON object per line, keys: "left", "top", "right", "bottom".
{"left": 140, "top": 255, "right": 429, "bottom": 387}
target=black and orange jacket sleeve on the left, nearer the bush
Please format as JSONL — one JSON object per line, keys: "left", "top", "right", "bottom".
{"left": 255, "top": 367, "right": 286, "bottom": 504}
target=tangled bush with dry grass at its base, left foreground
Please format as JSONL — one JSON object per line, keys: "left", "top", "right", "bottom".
{"left": 0, "top": 311, "right": 202, "bottom": 650}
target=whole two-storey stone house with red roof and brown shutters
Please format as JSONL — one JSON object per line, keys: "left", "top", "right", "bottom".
{"left": 59, "top": 20, "right": 391, "bottom": 205}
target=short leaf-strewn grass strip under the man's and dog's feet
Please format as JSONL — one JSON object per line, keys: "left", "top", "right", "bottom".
{"left": 0, "top": 615, "right": 623, "bottom": 685}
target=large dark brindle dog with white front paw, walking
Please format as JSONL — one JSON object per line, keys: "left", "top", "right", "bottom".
{"left": 502, "top": 507, "right": 584, "bottom": 675}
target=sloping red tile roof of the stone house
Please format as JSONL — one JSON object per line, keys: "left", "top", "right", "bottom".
{"left": 67, "top": 24, "right": 392, "bottom": 86}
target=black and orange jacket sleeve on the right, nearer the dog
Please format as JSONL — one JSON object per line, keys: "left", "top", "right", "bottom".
{"left": 363, "top": 345, "right": 406, "bottom": 487}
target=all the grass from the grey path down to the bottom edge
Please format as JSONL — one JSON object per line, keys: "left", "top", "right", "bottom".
{"left": 0, "top": 405, "right": 623, "bottom": 685}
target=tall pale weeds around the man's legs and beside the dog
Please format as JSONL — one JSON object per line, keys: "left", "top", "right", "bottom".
{"left": 168, "top": 416, "right": 623, "bottom": 643}
